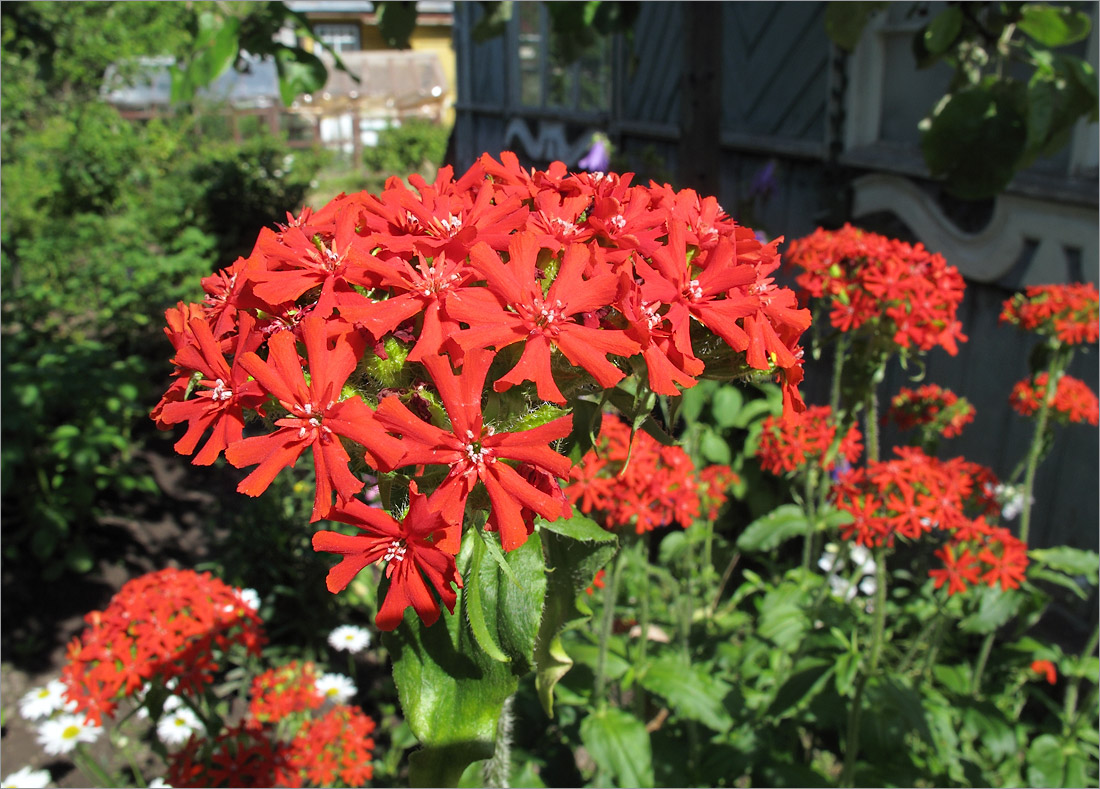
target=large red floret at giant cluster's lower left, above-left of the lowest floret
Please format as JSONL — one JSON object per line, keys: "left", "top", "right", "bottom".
{"left": 226, "top": 316, "right": 402, "bottom": 520}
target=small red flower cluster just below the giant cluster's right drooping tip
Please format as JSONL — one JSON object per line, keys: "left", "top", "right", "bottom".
{"left": 757, "top": 405, "right": 864, "bottom": 475}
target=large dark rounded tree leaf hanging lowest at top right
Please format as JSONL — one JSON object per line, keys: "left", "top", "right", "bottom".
{"left": 920, "top": 77, "right": 1027, "bottom": 199}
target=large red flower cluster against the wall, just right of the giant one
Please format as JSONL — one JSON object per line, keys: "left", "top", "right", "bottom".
{"left": 787, "top": 224, "right": 966, "bottom": 355}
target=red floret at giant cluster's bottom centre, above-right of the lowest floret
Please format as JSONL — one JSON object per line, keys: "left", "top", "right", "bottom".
{"left": 375, "top": 350, "right": 572, "bottom": 554}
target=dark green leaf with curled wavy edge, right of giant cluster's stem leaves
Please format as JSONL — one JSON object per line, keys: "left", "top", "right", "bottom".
{"left": 535, "top": 515, "right": 618, "bottom": 716}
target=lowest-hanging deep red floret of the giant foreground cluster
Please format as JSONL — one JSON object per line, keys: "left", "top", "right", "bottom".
{"left": 314, "top": 482, "right": 462, "bottom": 631}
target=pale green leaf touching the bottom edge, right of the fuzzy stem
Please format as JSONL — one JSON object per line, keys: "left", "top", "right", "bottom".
{"left": 581, "top": 706, "right": 653, "bottom": 787}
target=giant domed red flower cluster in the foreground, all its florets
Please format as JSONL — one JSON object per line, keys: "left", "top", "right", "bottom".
{"left": 153, "top": 149, "right": 810, "bottom": 628}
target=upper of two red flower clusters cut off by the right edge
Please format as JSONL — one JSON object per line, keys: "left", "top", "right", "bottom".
{"left": 1001, "top": 283, "right": 1100, "bottom": 346}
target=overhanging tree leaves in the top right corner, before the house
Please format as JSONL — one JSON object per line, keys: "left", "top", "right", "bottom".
{"left": 825, "top": 2, "right": 1098, "bottom": 199}
